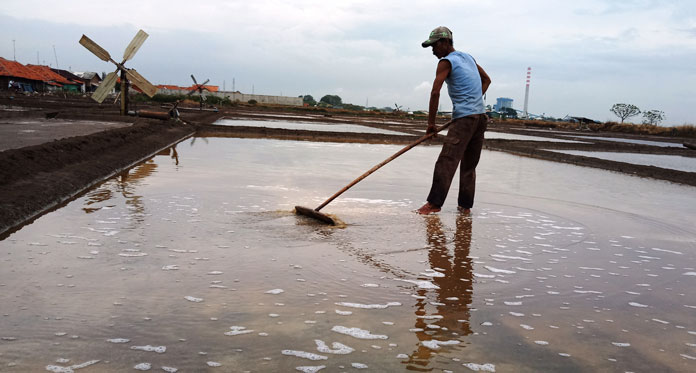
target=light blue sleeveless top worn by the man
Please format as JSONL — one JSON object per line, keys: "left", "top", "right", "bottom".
{"left": 443, "top": 51, "right": 486, "bottom": 119}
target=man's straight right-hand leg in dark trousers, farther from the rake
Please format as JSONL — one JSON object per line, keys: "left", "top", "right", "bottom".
{"left": 457, "top": 115, "right": 488, "bottom": 211}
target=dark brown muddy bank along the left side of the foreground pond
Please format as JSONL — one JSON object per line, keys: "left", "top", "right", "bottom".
{"left": 0, "top": 120, "right": 194, "bottom": 235}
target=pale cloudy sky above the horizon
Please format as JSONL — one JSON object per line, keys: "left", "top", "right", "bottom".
{"left": 0, "top": 0, "right": 696, "bottom": 125}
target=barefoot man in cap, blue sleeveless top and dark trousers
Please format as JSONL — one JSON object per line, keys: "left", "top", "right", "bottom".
{"left": 417, "top": 27, "right": 491, "bottom": 215}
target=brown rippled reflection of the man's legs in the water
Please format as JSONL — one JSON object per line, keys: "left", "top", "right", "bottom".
{"left": 404, "top": 214, "right": 473, "bottom": 371}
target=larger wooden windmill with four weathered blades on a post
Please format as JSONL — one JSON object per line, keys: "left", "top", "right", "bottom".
{"left": 80, "top": 30, "right": 157, "bottom": 115}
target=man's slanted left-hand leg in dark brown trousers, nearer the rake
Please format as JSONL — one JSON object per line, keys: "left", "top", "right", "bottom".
{"left": 428, "top": 117, "right": 476, "bottom": 209}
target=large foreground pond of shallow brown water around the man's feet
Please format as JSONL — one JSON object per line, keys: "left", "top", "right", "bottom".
{"left": 0, "top": 138, "right": 696, "bottom": 372}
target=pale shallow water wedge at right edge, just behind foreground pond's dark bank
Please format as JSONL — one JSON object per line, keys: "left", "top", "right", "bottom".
{"left": 550, "top": 150, "right": 696, "bottom": 172}
